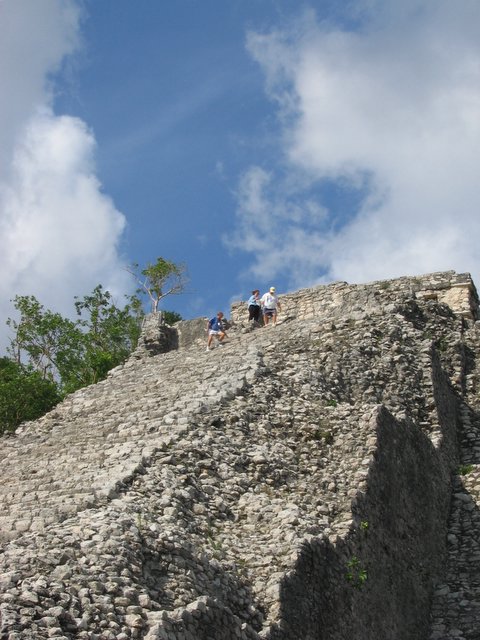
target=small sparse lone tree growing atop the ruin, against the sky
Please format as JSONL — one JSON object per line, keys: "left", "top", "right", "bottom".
{"left": 127, "top": 258, "right": 188, "bottom": 313}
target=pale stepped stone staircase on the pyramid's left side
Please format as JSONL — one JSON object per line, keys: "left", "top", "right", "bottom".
{"left": 0, "top": 330, "right": 259, "bottom": 540}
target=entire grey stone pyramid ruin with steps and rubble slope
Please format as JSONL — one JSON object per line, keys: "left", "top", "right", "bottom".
{"left": 0, "top": 272, "right": 480, "bottom": 640}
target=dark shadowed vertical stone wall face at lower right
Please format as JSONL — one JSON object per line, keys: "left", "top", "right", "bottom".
{"left": 268, "top": 408, "right": 450, "bottom": 640}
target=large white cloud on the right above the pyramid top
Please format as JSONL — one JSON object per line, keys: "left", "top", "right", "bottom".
{"left": 234, "top": 0, "right": 480, "bottom": 285}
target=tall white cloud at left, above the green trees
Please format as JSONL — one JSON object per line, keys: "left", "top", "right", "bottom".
{"left": 0, "top": 0, "right": 129, "bottom": 346}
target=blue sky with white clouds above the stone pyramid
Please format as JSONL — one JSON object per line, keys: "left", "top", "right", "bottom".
{"left": 0, "top": 0, "right": 480, "bottom": 348}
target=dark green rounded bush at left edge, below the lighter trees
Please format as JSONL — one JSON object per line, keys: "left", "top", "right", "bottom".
{"left": 0, "top": 358, "right": 60, "bottom": 434}
